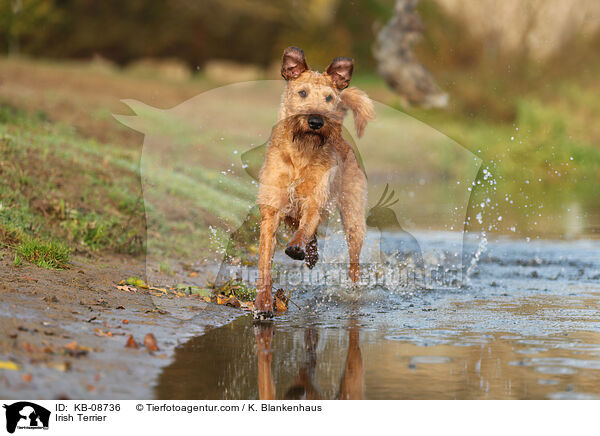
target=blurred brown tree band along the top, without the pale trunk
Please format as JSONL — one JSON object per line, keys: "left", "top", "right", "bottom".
{"left": 0, "top": 0, "right": 600, "bottom": 71}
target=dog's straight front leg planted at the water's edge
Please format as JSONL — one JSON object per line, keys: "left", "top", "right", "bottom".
{"left": 254, "top": 205, "right": 281, "bottom": 317}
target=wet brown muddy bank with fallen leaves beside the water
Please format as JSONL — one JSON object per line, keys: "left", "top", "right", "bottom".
{"left": 0, "top": 251, "right": 241, "bottom": 399}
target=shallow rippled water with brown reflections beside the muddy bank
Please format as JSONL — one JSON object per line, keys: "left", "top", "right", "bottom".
{"left": 155, "top": 237, "right": 600, "bottom": 399}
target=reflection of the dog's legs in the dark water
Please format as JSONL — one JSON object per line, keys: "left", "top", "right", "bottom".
{"left": 254, "top": 322, "right": 363, "bottom": 400}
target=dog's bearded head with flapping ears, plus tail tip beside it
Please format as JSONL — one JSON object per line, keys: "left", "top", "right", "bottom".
{"left": 279, "top": 47, "right": 374, "bottom": 145}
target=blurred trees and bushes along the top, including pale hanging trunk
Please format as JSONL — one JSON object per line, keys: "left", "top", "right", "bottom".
{"left": 0, "top": 0, "right": 600, "bottom": 112}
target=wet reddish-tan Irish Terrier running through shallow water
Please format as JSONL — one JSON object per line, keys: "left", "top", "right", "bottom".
{"left": 255, "top": 47, "right": 374, "bottom": 319}
